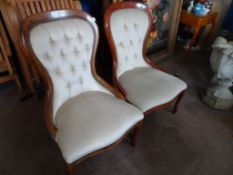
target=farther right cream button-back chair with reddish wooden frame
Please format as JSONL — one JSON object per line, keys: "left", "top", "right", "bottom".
{"left": 104, "top": 2, "right": 187, "bottom": 115}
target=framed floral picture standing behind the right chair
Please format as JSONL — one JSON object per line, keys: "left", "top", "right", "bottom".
{"left": 143, "top": 0, "right": 183, "bottom": 61}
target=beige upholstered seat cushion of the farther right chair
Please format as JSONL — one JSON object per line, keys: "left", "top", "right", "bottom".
{"left": 119, "top": 67, "right": 187, "bottom": 112}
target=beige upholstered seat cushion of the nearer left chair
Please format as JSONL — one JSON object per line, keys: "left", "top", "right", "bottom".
{"left": 55, "top": 91, "right": 143, "bottom": 163}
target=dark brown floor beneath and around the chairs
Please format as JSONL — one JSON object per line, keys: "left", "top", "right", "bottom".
{"left": 0, "top": 49, "right": 233, "bottom": 175}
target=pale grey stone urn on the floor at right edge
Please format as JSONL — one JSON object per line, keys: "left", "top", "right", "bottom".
{"left": 203, "top": 37, "right": 233, "bottom": 109}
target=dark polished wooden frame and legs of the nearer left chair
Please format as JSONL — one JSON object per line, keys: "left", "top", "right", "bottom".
{"left": 21, "top": 10, "right": 142, "bottom": 175}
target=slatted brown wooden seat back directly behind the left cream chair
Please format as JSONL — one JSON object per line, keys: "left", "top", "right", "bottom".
{"left": 0, "top": 0, "right": 81, "bottom": 95}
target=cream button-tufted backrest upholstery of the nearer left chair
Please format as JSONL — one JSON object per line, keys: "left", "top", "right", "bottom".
{"left": 24, "top": 11, "right": 109, "bottom": 119}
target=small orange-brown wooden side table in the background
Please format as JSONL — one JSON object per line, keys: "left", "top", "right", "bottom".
{"left": 180, "top": 10, "right": 218, "bottom": 51}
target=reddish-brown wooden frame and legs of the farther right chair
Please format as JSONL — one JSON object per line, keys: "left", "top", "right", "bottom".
{"left": 104, "top": 2, "right": 185, "bottom": 116}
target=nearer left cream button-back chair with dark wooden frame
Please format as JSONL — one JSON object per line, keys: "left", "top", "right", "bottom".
{"left": 21, "top": 10, "right": 143, "bottom": 174}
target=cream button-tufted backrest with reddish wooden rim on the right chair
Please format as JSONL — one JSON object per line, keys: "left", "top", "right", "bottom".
{"left": 105, "top": 2, "right": 150, "bottom": 77}
